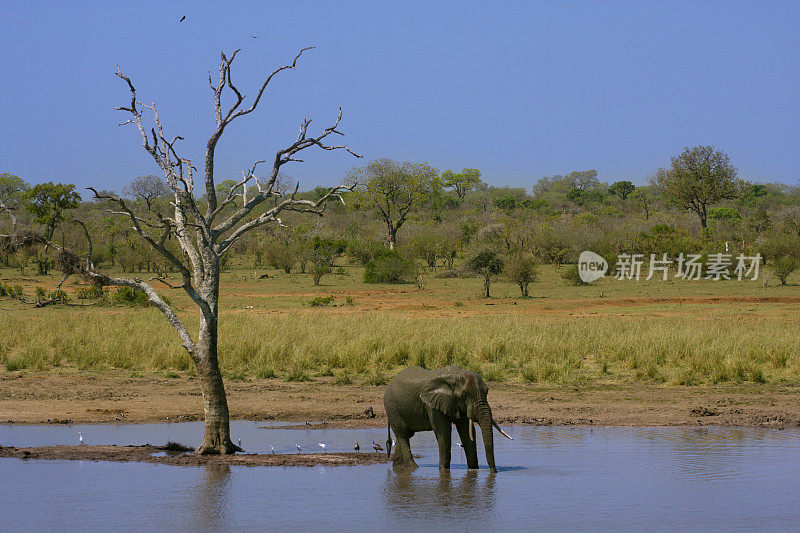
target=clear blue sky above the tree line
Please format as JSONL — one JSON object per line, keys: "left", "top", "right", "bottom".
{"left": 0, "top": 0, "right": 800, "bottom": 190}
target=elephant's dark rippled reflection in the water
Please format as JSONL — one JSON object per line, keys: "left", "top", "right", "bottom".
{"left": 383, "top": 469, "right": 497, "bottom": 519}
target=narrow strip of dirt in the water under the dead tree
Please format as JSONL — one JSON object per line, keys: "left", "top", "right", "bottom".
{"left": 0, "top": 444, "right": 387, "bottom": 466}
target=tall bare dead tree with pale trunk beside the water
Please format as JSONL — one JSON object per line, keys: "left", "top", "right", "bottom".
{"left": 3, "top": 47, "right": 361, "bottom": 454}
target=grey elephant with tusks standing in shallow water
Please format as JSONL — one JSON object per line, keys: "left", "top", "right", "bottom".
{"left": 383, "top": 365, "right": 511, "bottom": 472}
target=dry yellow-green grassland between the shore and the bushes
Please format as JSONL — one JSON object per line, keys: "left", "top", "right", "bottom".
{"left": 0, "top": 266, "right": 800, "bottom": 387}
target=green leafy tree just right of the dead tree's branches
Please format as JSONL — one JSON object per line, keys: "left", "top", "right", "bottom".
{"left": 348, "top": 159, "right": 439, "bottom": 250}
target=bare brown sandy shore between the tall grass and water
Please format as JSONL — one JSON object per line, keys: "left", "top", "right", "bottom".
{"left": 0, "top": 372, "right": 800, "bottom": 428}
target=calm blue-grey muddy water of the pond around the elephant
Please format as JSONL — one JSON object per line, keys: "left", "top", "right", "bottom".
{"left": 0, "top": 422, "right": 800, "bottom": 531}
